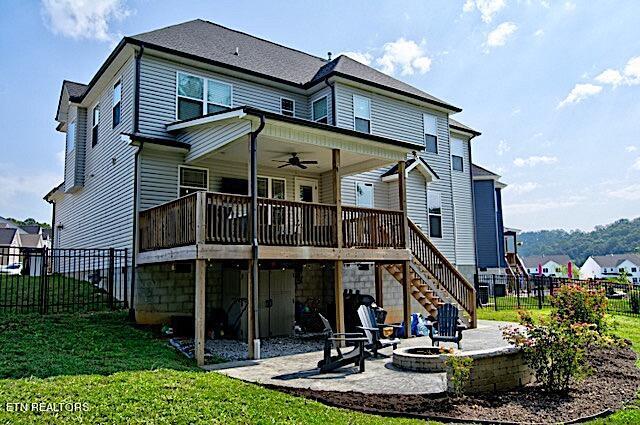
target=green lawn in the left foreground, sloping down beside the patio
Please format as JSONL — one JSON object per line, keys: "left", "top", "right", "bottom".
{"left": 0, "top": 314, "right": 424, "bottom": 424}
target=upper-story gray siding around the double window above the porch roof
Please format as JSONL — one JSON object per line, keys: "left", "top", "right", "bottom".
{"left": 140, "top": 54, "right": 310, "bottom": 137}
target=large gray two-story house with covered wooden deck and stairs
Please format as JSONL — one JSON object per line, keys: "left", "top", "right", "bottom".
{"left": 47, "top": 20, "right": 480, "bottom": 361}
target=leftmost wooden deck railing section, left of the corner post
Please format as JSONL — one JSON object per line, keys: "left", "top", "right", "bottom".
{"left": 138, "top": 193, "right": 196, "bottom": 251}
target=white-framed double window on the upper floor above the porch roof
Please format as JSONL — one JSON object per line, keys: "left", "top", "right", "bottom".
{"left": 176, "top": 71, "right": 233, "bottom": 120}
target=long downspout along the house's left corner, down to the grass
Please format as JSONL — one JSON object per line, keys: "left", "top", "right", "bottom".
{"left": 129, "top": 44, "right": 144, "bottom": 321}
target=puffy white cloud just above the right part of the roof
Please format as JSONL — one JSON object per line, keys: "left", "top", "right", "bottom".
{"left": 376, "top": 37, "right": 431, "bottom": 75}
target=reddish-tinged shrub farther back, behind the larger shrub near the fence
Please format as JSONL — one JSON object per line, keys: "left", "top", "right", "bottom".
{"left": 551, "top": 285, "right": 607, "bottom": 333}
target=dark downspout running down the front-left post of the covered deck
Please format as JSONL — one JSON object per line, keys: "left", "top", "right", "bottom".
{"left": 247, "top": 114, "right": 265, "bottom": 359}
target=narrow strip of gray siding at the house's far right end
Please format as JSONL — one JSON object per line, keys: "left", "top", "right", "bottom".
{"left": 451, "top": 136, "right": 476, "bottom": 265}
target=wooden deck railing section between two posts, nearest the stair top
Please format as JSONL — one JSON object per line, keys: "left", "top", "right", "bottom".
{"left": 342, "top": 206, "right": 405, "bottom": 248}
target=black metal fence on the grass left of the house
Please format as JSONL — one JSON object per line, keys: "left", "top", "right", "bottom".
{"left": 0, "top": 247, "right": 130, "bottom": 314}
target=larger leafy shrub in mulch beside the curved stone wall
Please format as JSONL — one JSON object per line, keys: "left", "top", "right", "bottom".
{"left": 504, "top": 312, "right": 599, "bottom": 392}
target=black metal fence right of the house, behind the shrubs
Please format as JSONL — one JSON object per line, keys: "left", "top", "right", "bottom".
{"left": 475, "top": 274, "right": 640, "bottom": 315}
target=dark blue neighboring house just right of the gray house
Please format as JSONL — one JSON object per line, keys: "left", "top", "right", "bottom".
{"left": 471, "top": 164, "right": 507, "bottom": 274}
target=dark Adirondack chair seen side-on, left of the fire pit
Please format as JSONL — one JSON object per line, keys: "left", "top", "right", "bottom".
{"left": 318, "top": 313, "right": 367, "bottom": 373}
